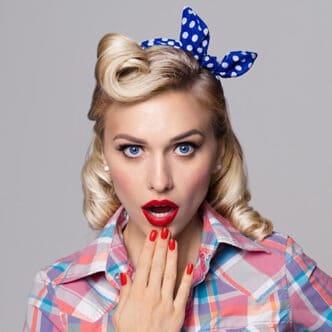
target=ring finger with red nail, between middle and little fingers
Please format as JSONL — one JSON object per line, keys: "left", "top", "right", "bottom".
{"left": 161, "top": 239, "right": 178, "bottom": 302}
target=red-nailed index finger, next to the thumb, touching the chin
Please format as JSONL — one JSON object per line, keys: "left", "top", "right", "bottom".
{"left": 133, "top": 229, "right": 158, "bottom": 287}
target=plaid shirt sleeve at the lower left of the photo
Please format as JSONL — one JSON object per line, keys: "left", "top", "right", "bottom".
{"left": 23, "top": 271, "right": 64, "bottom": 332}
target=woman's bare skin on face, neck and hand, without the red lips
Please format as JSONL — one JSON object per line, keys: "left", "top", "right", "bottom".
{"left": 103, "top": 91, "right": 218, "bottom": 331}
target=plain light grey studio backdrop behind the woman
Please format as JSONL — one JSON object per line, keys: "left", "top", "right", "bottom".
{"left": 0, "top": 0, "right": 332, "bottom": 332}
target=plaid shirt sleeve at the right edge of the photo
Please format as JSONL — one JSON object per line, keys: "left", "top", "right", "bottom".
{"left": 286, "top": 237, "right": 332, "bottom": 332}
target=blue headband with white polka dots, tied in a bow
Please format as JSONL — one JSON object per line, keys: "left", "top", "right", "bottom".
{"left": 141, "top": 7, "right": 257, "bottom": 78}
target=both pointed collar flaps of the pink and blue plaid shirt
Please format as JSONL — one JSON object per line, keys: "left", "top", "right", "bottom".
{"left": 56, "top": 202, "right": 269, "bottom": 288}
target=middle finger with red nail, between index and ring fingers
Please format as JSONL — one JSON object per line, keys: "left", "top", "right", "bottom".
{"left": 148, "top": 228, "right": 170, "bottom": 294}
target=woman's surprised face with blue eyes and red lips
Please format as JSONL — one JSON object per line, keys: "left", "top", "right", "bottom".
{"left": 104, "top": 92, "right": 217, "bottom": 237}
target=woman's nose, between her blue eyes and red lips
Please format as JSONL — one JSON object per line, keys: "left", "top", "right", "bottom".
{"left": 147, "top": 156, "right": 174, "bottom": 193}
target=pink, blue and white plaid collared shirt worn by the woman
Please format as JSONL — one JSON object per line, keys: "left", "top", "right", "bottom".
{"left": 24, "top": 203, "right": 332, "bottom": 332}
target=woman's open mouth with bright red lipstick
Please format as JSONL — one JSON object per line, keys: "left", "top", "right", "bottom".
{"left": 141, "top": 199, "right": 179, "bottom": 227}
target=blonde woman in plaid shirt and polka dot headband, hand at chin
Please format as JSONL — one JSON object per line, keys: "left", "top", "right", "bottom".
{"left": 25, "top": 8, "right": 332, "bottom": 331}
